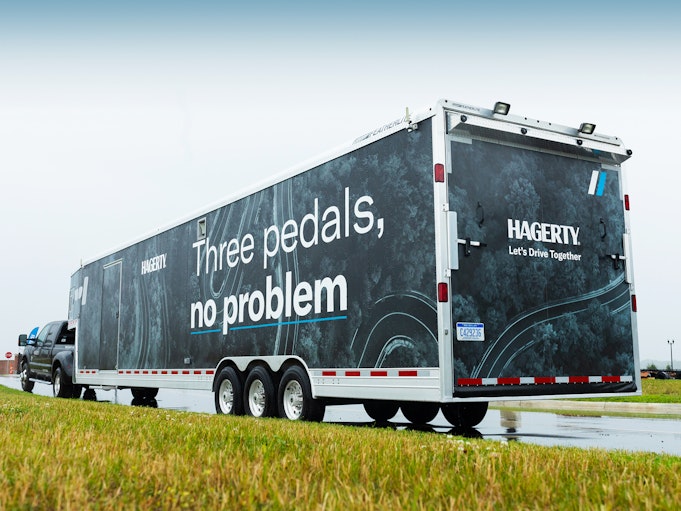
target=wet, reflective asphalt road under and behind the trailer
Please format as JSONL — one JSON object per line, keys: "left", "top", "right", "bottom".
{"left": 0, "top": 376, "right": 681, "bottom": 456}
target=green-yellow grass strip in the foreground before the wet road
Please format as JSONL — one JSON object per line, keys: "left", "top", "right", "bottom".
{"left": 0, "top": 387, "right": 681, "bottom": 510}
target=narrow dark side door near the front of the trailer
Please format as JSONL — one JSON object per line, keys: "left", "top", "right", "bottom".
{"left": 99, "top": 260, "right": 122, "bottom": 370}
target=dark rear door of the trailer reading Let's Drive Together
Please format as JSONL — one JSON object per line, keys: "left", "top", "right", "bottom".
{"left": 447, "top": 122, "right": 635, "bottom": 395}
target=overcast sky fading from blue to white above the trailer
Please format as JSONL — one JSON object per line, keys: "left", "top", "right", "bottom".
{"left": 0, "top": 0, "right": 681, "bottom": 361}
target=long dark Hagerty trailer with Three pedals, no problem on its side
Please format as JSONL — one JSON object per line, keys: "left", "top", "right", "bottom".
{"left": 68, "top": 100, "right": 641, "bottom": 427}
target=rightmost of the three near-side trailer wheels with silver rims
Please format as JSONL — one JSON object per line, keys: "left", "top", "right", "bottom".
{"left": 278, "top": 366, "right": 325, "bottom": 422}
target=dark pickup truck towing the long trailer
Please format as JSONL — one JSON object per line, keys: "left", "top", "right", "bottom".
{"left": 19, "top": 321, "right": 82, "bottom": 397}
